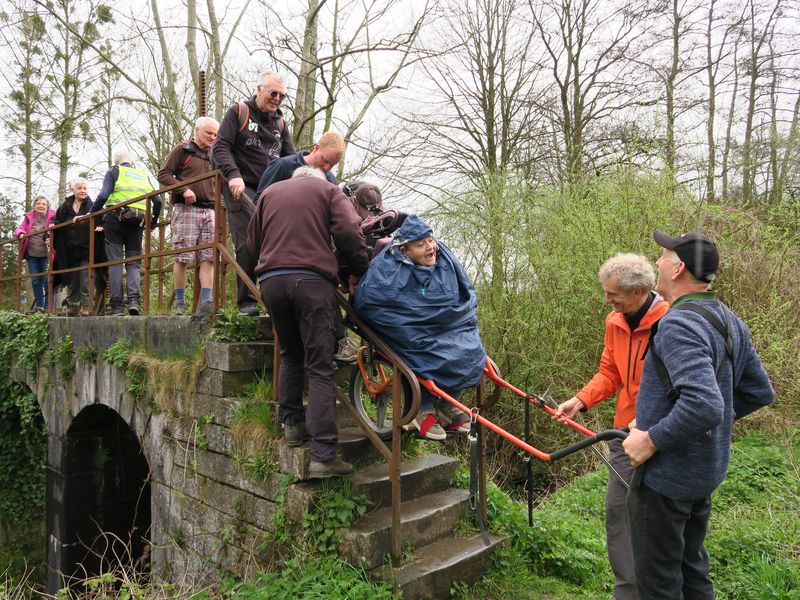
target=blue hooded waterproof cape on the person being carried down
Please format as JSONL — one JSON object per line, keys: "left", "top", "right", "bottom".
{"left": 355, "top": 215, "right": 486, "bottom": 391}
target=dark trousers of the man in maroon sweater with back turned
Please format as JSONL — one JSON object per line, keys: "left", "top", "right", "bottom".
{"left": 261, "top": 274, "right": 339, "bottom": 462}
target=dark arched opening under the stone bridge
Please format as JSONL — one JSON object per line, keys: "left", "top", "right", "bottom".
{"left": 47, "top": 404, "right": 151, "bottom": 593}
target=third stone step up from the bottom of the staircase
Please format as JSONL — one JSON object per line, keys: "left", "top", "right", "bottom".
{"left": 353, "top": 454, "right": 458, "bottom": 508}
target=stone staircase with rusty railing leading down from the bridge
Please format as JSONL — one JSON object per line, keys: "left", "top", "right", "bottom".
{"left": 278, "top": 410, "right": 505, "bottom": 600}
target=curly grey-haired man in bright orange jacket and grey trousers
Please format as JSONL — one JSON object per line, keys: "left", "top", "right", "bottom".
{"left": 554, "top": 254, "right": 669, "bottom": 600}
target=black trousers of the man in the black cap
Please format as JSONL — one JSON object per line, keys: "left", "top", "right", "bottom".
{"left": 627, "top": 465, "right": 714, "bottom": 600}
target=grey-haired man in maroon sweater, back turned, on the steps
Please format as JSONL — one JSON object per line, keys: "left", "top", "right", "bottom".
{"left": 247, "top": 167, "right": 368, "bottom": 478}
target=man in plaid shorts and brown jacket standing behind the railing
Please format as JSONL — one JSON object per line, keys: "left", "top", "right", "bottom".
{"left": 158, "top": 117, "right": 219, "bottom": 316}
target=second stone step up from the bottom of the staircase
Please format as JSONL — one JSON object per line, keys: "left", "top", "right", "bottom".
{"left": 339, "top": 488, "right": 469, "bottom": 571}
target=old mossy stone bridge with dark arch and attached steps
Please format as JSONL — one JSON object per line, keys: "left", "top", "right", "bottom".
{"left": 13, "top": 316, "right": 502, "bottom": 600}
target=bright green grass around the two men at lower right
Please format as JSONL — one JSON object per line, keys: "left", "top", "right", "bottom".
{"left": 454, "top": 432, "right": 800, "bottom": 600}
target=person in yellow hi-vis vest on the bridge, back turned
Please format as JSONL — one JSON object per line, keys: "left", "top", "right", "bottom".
{"left": 92, "top": 149, "right": 161, "bottom": 316}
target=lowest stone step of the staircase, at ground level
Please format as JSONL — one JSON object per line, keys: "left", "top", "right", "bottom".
{"left": 370, "top": 534, "right": 506, "bottom": 600}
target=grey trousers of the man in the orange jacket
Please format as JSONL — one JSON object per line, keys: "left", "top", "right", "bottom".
{"left": 606, "top": 440, "right": 639, "bottom": 600}
